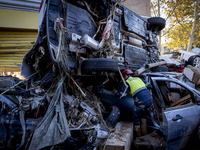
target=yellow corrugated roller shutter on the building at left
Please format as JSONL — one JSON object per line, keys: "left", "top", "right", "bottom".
{"left": 0, "top": 29, "right": 37, "bottom": 72}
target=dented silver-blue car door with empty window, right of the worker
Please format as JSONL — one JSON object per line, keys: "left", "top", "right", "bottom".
{"left": 152, "top": 77, "right": 200, "bottom": 150}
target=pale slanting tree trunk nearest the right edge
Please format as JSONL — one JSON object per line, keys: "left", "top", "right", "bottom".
{"left": 187, "top": 0, "right": 199, "bottom": 52}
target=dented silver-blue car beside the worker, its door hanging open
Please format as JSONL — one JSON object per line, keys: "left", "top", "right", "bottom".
{"left": 99, "top": 73, "right": 200, "bottom": 150}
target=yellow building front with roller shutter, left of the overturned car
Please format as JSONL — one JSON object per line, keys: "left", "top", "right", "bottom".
{"left": 0, "top": 0, "right": 41, "bottom": 72}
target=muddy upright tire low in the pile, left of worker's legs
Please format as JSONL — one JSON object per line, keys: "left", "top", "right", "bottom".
{"left": 106, "top": 106, "right": 120, "bottom": 128}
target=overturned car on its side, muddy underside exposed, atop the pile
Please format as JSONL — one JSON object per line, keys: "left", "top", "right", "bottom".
{"left": 21, "top": 0, "right": 165, "bottom": 77}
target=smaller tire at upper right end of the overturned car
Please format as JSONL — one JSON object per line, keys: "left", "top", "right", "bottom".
{"left": 148, "top": 17, "right": 165, "bottom": 31}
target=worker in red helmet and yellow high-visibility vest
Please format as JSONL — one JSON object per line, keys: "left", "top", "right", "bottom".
{"left": 113, "top": 69, "right": 153, "bottom": 136}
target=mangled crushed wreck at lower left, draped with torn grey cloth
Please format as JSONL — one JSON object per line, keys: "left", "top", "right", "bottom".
{"left": 0, "top": 77, "right": 120, "bottom": 150}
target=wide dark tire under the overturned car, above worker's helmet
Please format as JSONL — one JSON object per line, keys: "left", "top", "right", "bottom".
{"left": 82, "top": 58, "right": 118, "bottom": 73}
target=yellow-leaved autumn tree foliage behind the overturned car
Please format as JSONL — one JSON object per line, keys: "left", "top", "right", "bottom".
{"left": 151, "top": 0, "right": 200, "bottom": 51}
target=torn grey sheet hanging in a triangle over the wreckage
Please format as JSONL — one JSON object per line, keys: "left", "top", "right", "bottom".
{"left": 28, "top": 77, "right": 71, "bottom": 150}
